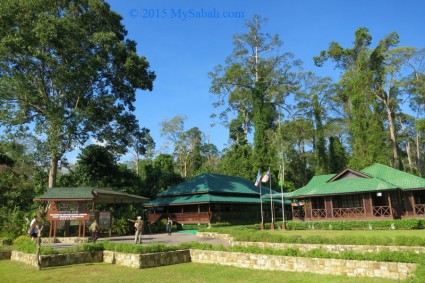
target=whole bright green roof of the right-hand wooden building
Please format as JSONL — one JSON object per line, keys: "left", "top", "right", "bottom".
{"left": 291, "top": 163, "right": 425, "bottom": 197}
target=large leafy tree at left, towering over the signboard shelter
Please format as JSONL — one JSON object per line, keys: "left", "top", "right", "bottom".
{"left": 0, "top": 0, "right": 155, "bottom": 187}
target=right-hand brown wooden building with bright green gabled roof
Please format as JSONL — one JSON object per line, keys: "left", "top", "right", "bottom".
{"left": 287, "top": 163, "right": 425, "bottom": 221}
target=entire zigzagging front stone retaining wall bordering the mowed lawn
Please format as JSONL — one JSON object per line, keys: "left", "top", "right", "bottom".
{"left": 6, "top": 250, "right": 416, "bottom": 280}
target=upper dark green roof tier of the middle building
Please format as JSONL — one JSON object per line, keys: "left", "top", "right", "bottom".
{"left": 158, "top": 173, "right": 259, "bottom": 197}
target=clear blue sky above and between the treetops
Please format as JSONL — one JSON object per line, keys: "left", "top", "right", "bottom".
{"left": 102, "top": 0, "right": 425, "bottom": 160}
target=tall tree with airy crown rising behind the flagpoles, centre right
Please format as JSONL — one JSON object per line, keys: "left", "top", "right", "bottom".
{"left": 210, "top": 16, "right": 300, "bottom": 174}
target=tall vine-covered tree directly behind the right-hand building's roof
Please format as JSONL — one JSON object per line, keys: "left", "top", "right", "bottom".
{"left": 314, "top": 28, "right": 388, "bottom": 169}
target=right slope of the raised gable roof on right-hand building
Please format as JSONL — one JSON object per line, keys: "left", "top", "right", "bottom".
{"left": 361, "top": 163, "right": 425, "bottom": 190}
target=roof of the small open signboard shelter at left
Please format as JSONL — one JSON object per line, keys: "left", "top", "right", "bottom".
{"left": 34, "top": 187, "right": 149, "bottom": 203}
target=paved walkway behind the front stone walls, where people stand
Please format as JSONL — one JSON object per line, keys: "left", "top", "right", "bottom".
{"left": 44, "top": 232, "right": 229, "bottom": 249}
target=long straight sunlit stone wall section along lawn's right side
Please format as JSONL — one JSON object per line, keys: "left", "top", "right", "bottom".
{"left": 190, "top": 250, "right": 416, "bottom": 280}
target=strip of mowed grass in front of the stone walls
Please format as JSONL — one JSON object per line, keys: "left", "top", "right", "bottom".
{"left": 0, "top": 260, "right": 400, "bottom": 283}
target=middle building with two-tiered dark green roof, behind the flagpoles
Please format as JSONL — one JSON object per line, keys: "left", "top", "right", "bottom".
{"left": 145, "top": 173, "right": 284, "bottom": 223}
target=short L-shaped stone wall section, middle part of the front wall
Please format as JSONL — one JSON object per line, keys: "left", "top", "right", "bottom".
{"left": 103, "top": 250, "right": 191, "bottom": 268}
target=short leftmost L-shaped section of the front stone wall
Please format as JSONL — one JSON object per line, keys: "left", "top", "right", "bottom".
{"left": 10, "top": 251, "right": 103, "bottom": 268}
